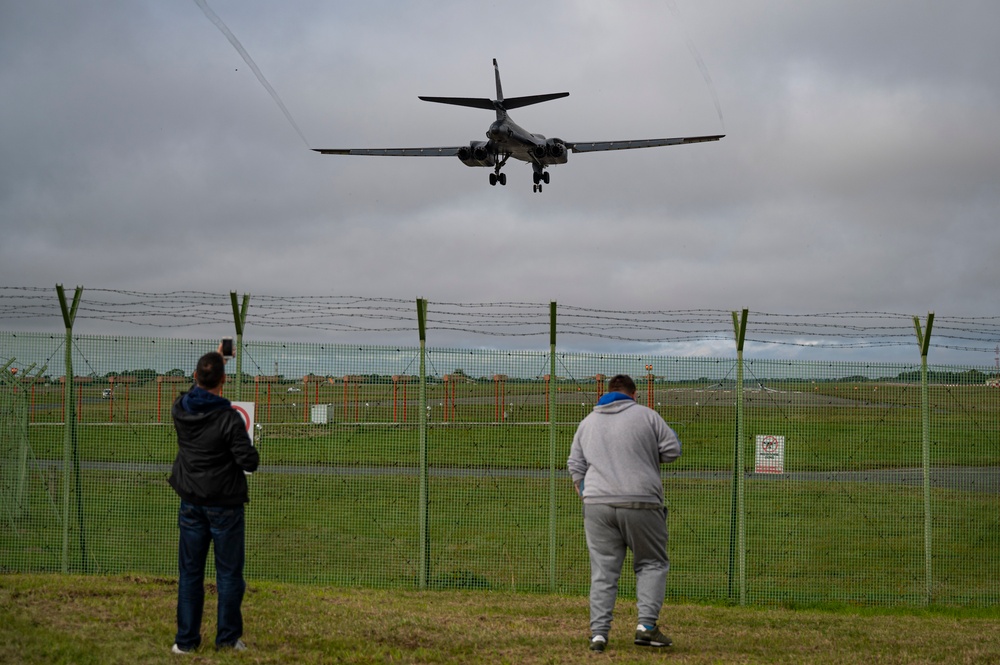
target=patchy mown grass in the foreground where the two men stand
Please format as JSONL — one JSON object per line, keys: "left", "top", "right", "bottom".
{"left": 0, "top": 574, "right": 1000, "bottom": 665}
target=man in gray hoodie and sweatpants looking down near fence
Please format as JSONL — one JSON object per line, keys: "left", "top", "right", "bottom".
{"left": 566, "top": 374, "right": 681, "bottom": 651}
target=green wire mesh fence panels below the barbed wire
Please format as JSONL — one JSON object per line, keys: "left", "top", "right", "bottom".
{"left": 0, "top": 288, "right": 1000, "bottom": 605}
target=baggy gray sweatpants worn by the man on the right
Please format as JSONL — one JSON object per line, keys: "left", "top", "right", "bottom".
{"left": 583, "top": 503, "right": 670, "bottom": 637}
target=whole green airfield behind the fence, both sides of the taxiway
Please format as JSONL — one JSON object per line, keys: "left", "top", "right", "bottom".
{"left": 0, "top": 382, "right": 1000, "bottom": 606}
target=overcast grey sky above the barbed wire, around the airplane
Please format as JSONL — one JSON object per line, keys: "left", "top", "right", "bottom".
{"left": 0, "top": 0, "right": 1000, "bottom": 362}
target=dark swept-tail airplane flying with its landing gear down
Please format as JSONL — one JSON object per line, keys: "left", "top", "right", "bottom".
{"left": 312, "top": 58, "right": 725, "bottom": 193}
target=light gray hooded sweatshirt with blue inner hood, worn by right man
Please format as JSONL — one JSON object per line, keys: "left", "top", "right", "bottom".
{"left": 566, "top": 399, "right": 681, "bottom": 506}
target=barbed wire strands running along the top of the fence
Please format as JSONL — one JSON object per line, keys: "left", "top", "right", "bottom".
{"left": 0, "top": 287, "right": 1000, "bottom": 353}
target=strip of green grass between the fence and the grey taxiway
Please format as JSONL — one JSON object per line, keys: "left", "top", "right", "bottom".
{"left": 0, "top": 471, "right": 1000, "bottom": 606}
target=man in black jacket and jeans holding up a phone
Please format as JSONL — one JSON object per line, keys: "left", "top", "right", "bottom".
{"left": 169, "top": 346, "right": 260, "bottom": 653}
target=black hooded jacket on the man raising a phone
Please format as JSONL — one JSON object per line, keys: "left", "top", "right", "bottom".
{"left": 168, "top": 386, "right": 260, "bottom": 506}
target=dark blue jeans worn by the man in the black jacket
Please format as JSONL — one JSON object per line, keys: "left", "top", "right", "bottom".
{"left": 176, "top": 500, "right": 246, "bottom": 651}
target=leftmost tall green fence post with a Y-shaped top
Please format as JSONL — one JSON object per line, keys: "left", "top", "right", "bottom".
{"left": 56, "top": 284, "right": 87, "bottom": 573}
